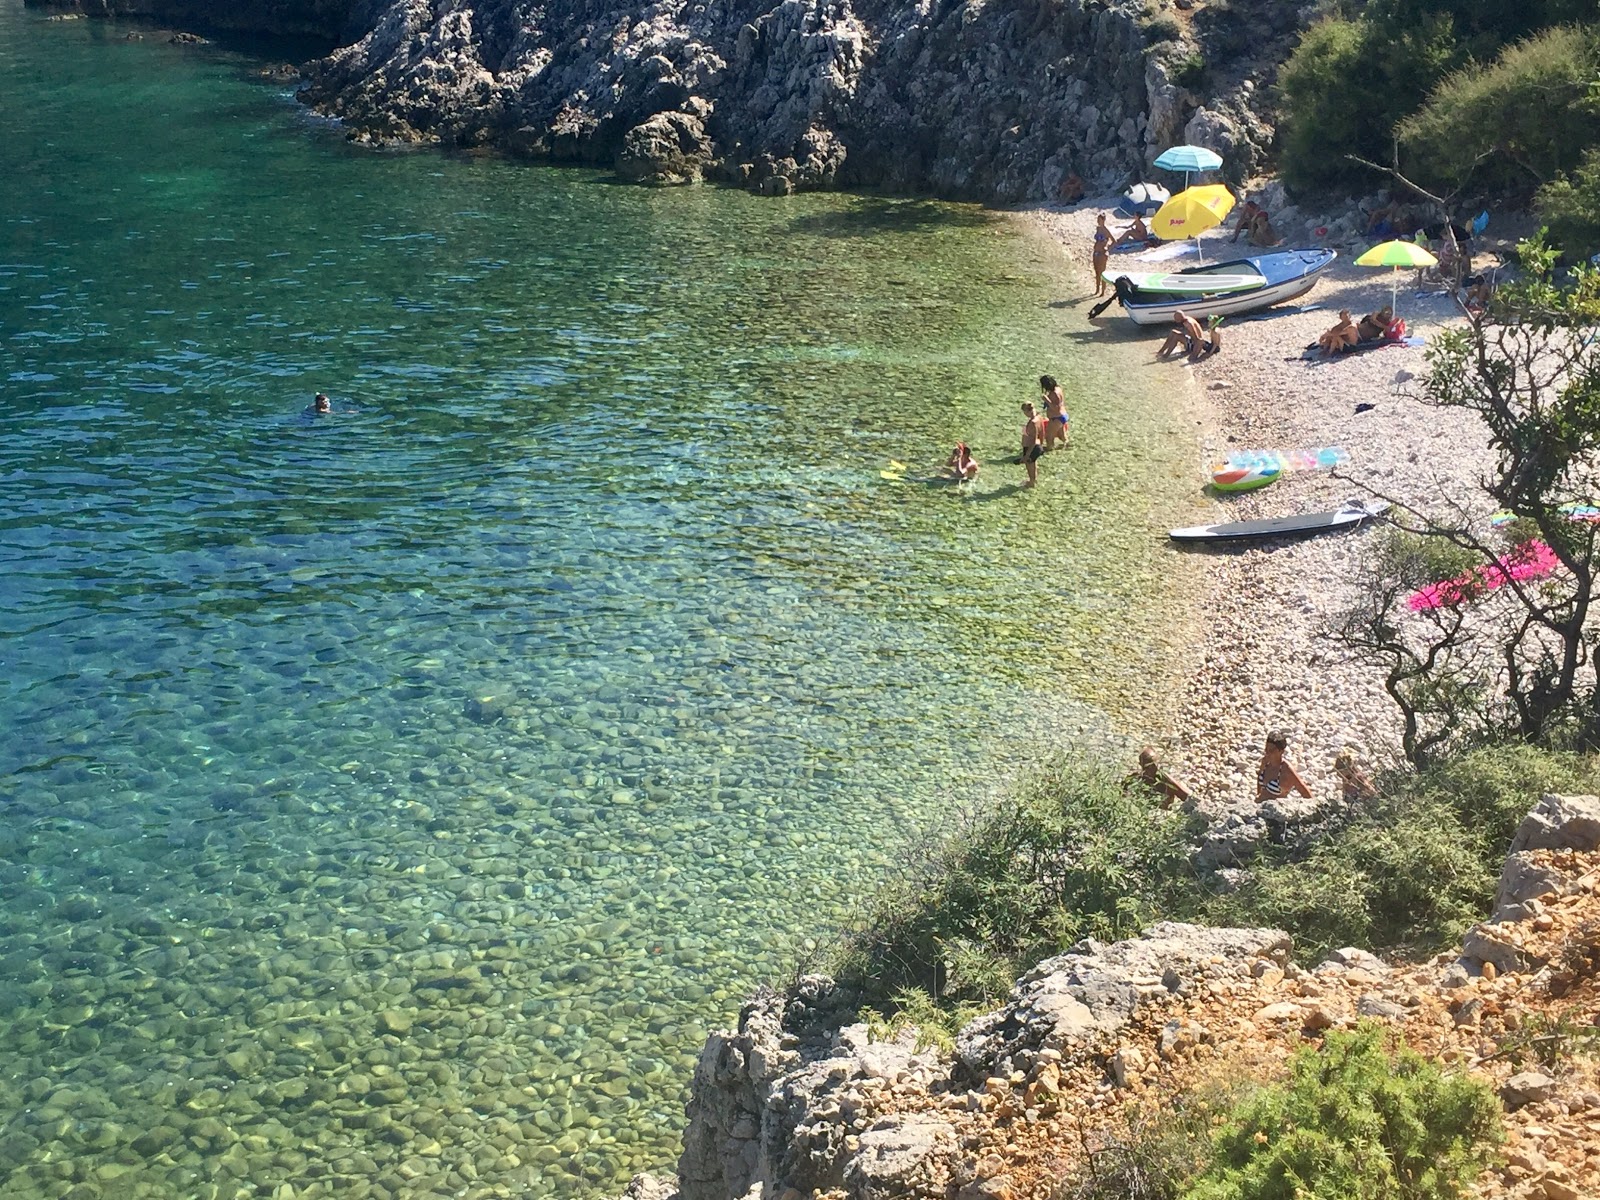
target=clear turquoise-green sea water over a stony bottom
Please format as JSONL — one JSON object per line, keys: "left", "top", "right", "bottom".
{"left": 0, "top": 0, "right": 1187, "bottom": 1200}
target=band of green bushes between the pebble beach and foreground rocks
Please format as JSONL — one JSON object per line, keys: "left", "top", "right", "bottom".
{"left": 827, "top": 746, "right": 1595, "bottom": 1018}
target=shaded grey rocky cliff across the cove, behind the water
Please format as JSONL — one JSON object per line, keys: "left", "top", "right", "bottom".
{"left": 291, "top": 0, "right": 1294, "bottom": 200}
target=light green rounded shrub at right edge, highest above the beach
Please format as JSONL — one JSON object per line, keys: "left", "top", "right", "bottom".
{"left": 1400, "top": 26, "right": 1600, "bottom": 195}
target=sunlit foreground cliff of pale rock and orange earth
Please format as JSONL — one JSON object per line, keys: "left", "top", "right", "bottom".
{"left": 627, "top": 795, "right": 1600, "bottom": 1200}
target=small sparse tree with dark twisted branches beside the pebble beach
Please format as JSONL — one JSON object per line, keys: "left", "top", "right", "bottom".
{"left": 1336, "top": 237, "right": 1600, "bottom": 765}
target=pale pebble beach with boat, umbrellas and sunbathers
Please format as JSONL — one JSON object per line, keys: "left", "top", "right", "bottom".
{"left": 1027, "top": 198, "right": 1493, "bottom": 818}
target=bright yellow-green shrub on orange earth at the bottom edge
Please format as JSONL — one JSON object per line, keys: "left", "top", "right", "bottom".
{"left": 1184, "top": 1024, "right": 1504, "bottom": 1200}
